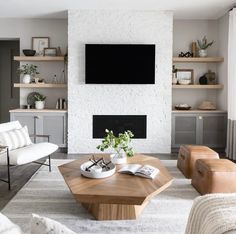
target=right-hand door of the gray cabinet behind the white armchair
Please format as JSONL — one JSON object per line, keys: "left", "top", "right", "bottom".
{"left": 42, "top": 114, "right": 67, "bottom": 147}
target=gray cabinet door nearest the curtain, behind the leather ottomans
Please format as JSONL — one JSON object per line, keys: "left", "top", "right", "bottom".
{"left": 202, "top": 114, "right": 227, "bottom": 148}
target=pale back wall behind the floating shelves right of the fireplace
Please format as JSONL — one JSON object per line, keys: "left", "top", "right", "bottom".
{"left": 172, "top": 20, "right": 227, "bottom": 109}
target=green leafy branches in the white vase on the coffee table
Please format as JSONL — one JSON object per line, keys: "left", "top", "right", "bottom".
{"left": 97, "top": 129, "right": 134, "bottom": 157}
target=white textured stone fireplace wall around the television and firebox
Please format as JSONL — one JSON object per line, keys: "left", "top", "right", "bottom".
{"left": 68, "top": 10, "right": 173, "bottom": 153}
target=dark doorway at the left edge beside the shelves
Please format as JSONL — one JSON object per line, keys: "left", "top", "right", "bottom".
{"left": 0, "top": 39, "right": 20, "bottom": 123}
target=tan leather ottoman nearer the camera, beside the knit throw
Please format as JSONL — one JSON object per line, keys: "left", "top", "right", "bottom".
{"left": 192, "top": 159, "right": 236, "bottom": 195}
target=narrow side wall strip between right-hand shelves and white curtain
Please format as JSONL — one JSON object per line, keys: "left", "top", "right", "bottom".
{"left": 217, "top": 13, "right": 229, "bottom": 110}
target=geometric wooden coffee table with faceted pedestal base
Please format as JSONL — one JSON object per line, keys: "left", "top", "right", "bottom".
{"left": 59, "top": 154, "right": 173, "bottom": 220}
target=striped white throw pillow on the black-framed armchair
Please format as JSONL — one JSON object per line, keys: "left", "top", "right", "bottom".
{"left": 0, "top": 126, "right": 32, "bottom": 150}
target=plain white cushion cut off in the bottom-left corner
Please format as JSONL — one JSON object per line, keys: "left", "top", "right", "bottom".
{"left": 0, "top": 213, "right": 23, "bottom": 234}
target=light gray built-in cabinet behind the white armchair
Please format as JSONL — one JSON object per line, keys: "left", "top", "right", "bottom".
{"left": 10, "top": 111, "right": 67, "bottom": 147}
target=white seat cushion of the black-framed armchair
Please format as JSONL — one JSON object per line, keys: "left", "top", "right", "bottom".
{"left": 0, "top": 142, "right": 58, "bottom": 165}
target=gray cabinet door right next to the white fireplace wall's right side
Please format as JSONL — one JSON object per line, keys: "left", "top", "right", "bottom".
{"left": 172, "top": 115, "right": 197, "bottom": 147}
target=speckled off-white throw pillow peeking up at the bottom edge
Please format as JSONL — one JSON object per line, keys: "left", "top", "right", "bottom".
{"left": 31, "top": 214, "right": 76, "bottom": 234}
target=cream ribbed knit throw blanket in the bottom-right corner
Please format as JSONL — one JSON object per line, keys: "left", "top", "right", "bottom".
{"left": 185, "top": 193, "right": 236, "bottom": 234}
